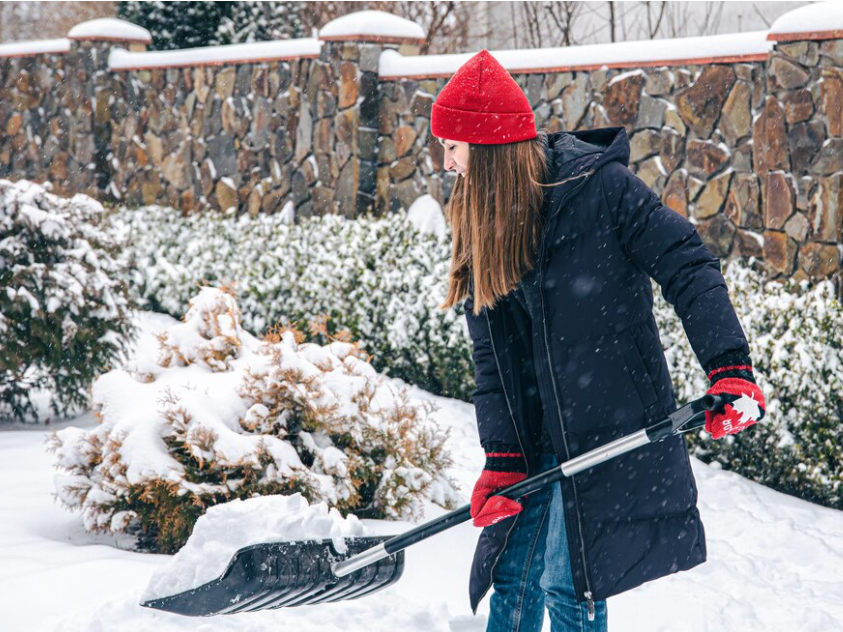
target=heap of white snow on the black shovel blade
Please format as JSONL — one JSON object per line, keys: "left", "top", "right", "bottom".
{"left": 141, "top": 494, "right": 370, "bottom": 601}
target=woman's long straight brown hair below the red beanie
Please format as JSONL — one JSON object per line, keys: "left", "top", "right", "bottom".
{"left": 439, "top": 131, "right": 548, "bottom": 315}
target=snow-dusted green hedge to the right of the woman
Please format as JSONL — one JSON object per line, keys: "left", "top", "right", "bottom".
{"left": 656, "top": 260, "right": 843, "bottom": 509}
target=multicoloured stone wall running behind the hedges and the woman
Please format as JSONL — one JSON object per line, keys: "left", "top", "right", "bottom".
{"left": 0, "top": 10, "right": 843, "bottom": 288}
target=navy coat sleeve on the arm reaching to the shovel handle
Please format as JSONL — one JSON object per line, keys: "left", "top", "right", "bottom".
{"left": 601, "top": 162, "right": 749, "bottom": 372}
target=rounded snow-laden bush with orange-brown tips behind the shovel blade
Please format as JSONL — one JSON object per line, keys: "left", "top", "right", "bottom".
{"left": 50, "top": 287, "right": 456, "bottom": 551}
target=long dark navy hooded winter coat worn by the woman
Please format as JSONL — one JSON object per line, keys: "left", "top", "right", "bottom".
{"left": 464, "top": 127, "right": 749, "bottom": 611}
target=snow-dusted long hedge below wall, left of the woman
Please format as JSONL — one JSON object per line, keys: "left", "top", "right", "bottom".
{"left": 107, "top": 206, "right": 473, "bottom": 399}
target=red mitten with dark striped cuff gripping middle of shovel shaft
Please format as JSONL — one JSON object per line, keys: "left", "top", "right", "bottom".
{"left": 470, "top": 444, "right": 527, "bottom": 527}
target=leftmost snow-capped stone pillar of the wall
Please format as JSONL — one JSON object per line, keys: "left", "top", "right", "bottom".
{"left": 67, "top": 18, "right": 152, "bottom": 198}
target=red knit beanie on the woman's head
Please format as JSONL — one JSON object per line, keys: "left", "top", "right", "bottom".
{"left": 430, "top": 49, "right": 536, "bottom": 145}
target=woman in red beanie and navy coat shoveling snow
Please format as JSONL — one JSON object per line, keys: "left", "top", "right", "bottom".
{"left": 431, "top": 50, "right": 765, "bottom": 632}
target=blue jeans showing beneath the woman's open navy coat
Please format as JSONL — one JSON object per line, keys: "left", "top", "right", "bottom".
{"left": 486, "top": 454, "right": 607, "bottom": 632}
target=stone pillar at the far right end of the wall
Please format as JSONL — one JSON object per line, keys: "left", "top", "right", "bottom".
{"left": 764, "top": 12, "right": 843, "bottom": 289}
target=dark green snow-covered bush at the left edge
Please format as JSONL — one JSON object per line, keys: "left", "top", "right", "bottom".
{"left": 0, "top": 180, "right": 133, "bottom": 420}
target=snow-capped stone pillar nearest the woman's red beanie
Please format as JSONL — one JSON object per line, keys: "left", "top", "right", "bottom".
{"left": 316, "top": 11, "right": 424, "bottom": 217}
